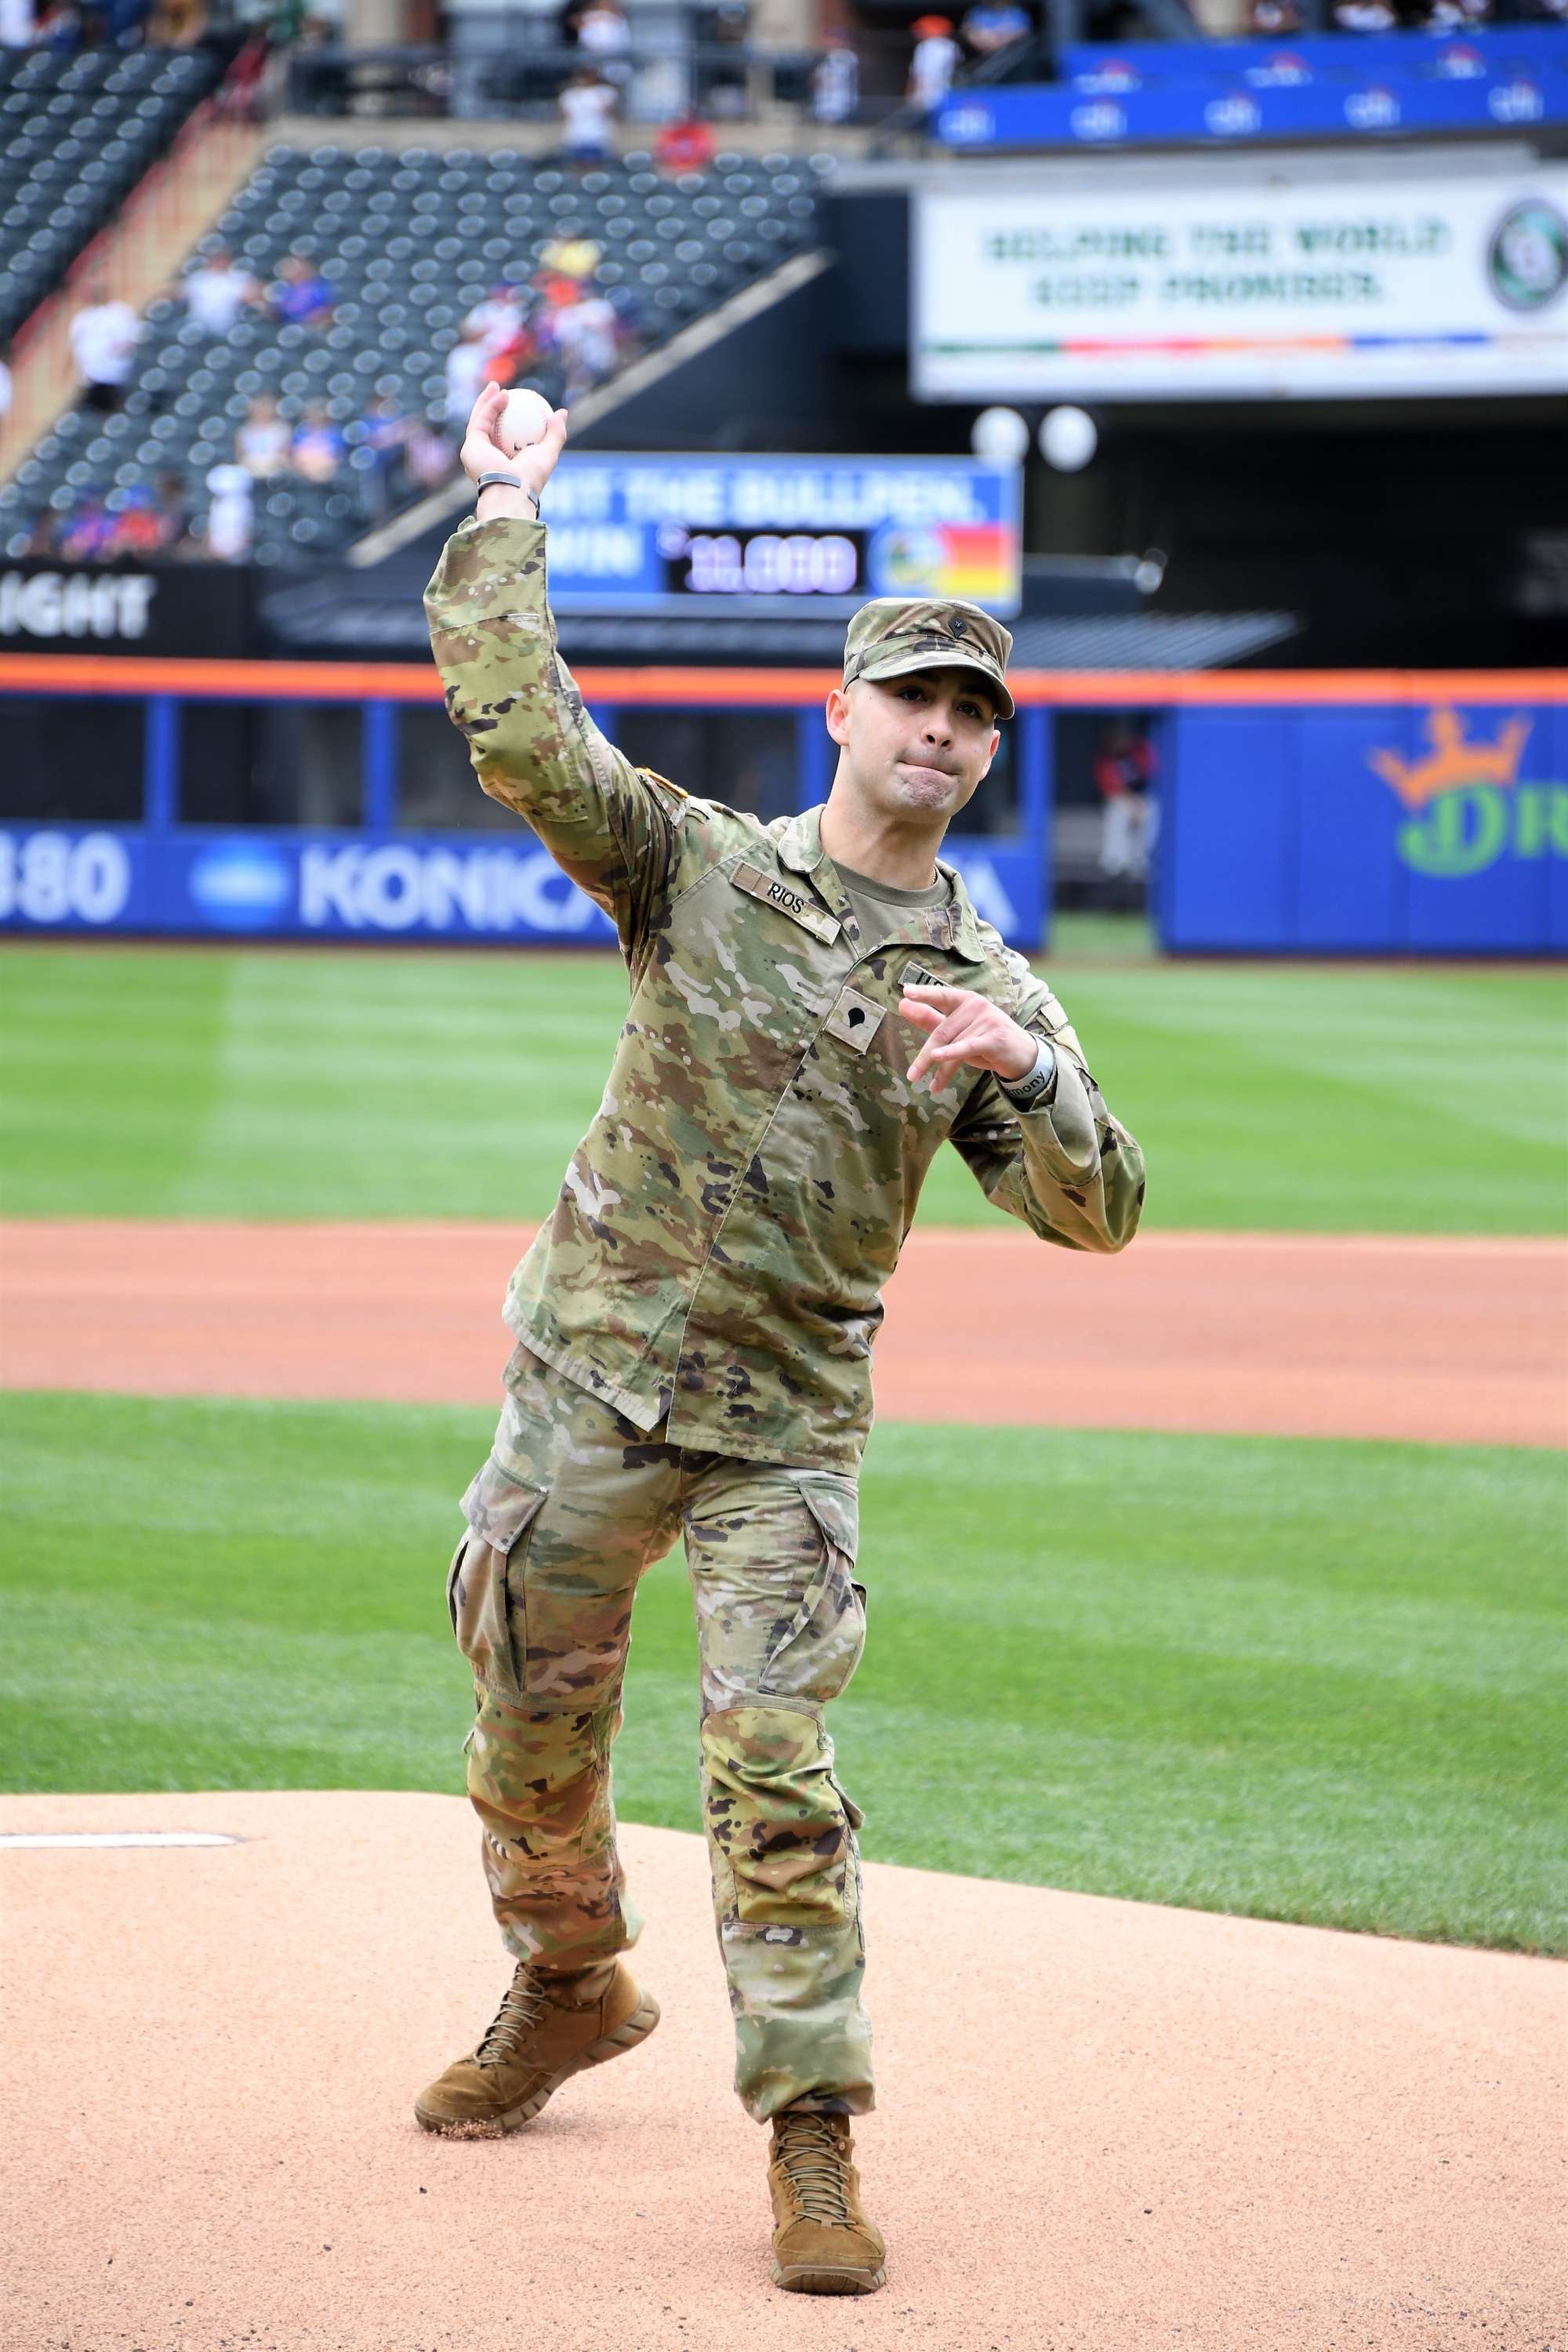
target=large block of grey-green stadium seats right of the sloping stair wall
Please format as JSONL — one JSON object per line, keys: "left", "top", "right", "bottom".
{"left": 0, "top": 146, "right": 832, "bottom": 564}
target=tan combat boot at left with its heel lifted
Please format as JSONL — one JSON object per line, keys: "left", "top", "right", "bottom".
{"left": 414, "top": 1959, "right": 659, "bottom": 2140}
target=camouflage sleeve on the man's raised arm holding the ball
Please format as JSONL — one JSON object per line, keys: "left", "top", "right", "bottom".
{"left": 426, "top": 517, "right": 684, "bottom": 957}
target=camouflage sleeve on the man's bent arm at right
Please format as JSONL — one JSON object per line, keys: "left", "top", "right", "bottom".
{"left": 952, "top": 955, "right": 1142, "bottom": 1254}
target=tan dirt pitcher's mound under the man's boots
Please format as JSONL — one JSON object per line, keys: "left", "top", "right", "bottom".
{"left": 0, "top": 1795, "right": 1568, "bottom": 2352}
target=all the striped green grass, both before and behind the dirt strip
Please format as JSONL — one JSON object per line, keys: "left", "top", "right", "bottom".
{"left": 0, "top": 946, "right": 1568, "bottom": 1950}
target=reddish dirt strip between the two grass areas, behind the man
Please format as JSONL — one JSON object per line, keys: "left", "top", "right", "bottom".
{"left": 0, "top": 1221, "right": 1568, "bottom": 1446}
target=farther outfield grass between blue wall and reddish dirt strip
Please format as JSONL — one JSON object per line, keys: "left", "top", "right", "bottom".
{"left": 0, "top": 924, "right": 1568, "bottom": 1232}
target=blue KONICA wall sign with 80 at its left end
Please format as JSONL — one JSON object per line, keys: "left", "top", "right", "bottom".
{"left": 0, "top": 826, "right": 616, "bottom": 946}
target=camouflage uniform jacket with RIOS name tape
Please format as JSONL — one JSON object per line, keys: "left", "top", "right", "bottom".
{"left": 426, "top": 520, "right": 1142, "bottom": 1470}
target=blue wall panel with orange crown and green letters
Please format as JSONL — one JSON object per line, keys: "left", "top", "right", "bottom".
{"left": 1159, "top": 701, "right": 1568, "bottom": 955}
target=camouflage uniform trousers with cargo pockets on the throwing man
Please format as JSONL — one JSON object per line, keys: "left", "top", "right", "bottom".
{"left": 449, "top": 1348, "right": 872, "bottom": 2119}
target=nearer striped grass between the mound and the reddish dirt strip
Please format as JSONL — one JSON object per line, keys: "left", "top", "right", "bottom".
{"left": 0, "top": 1395, "right": 1568, "bottom": 1950}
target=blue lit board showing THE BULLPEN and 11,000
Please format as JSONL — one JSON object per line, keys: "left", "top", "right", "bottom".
{"left": 543, "top": 449, "right": 1022, "bottom": 619}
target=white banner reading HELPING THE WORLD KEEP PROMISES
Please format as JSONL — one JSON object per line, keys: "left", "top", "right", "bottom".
{"left": 912, "top": 158, "right": 1568, "bottom": 400}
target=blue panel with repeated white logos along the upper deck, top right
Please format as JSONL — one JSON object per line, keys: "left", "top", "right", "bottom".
{"left": 935, "top": 24, "right": 1568, "bottom": 148}
